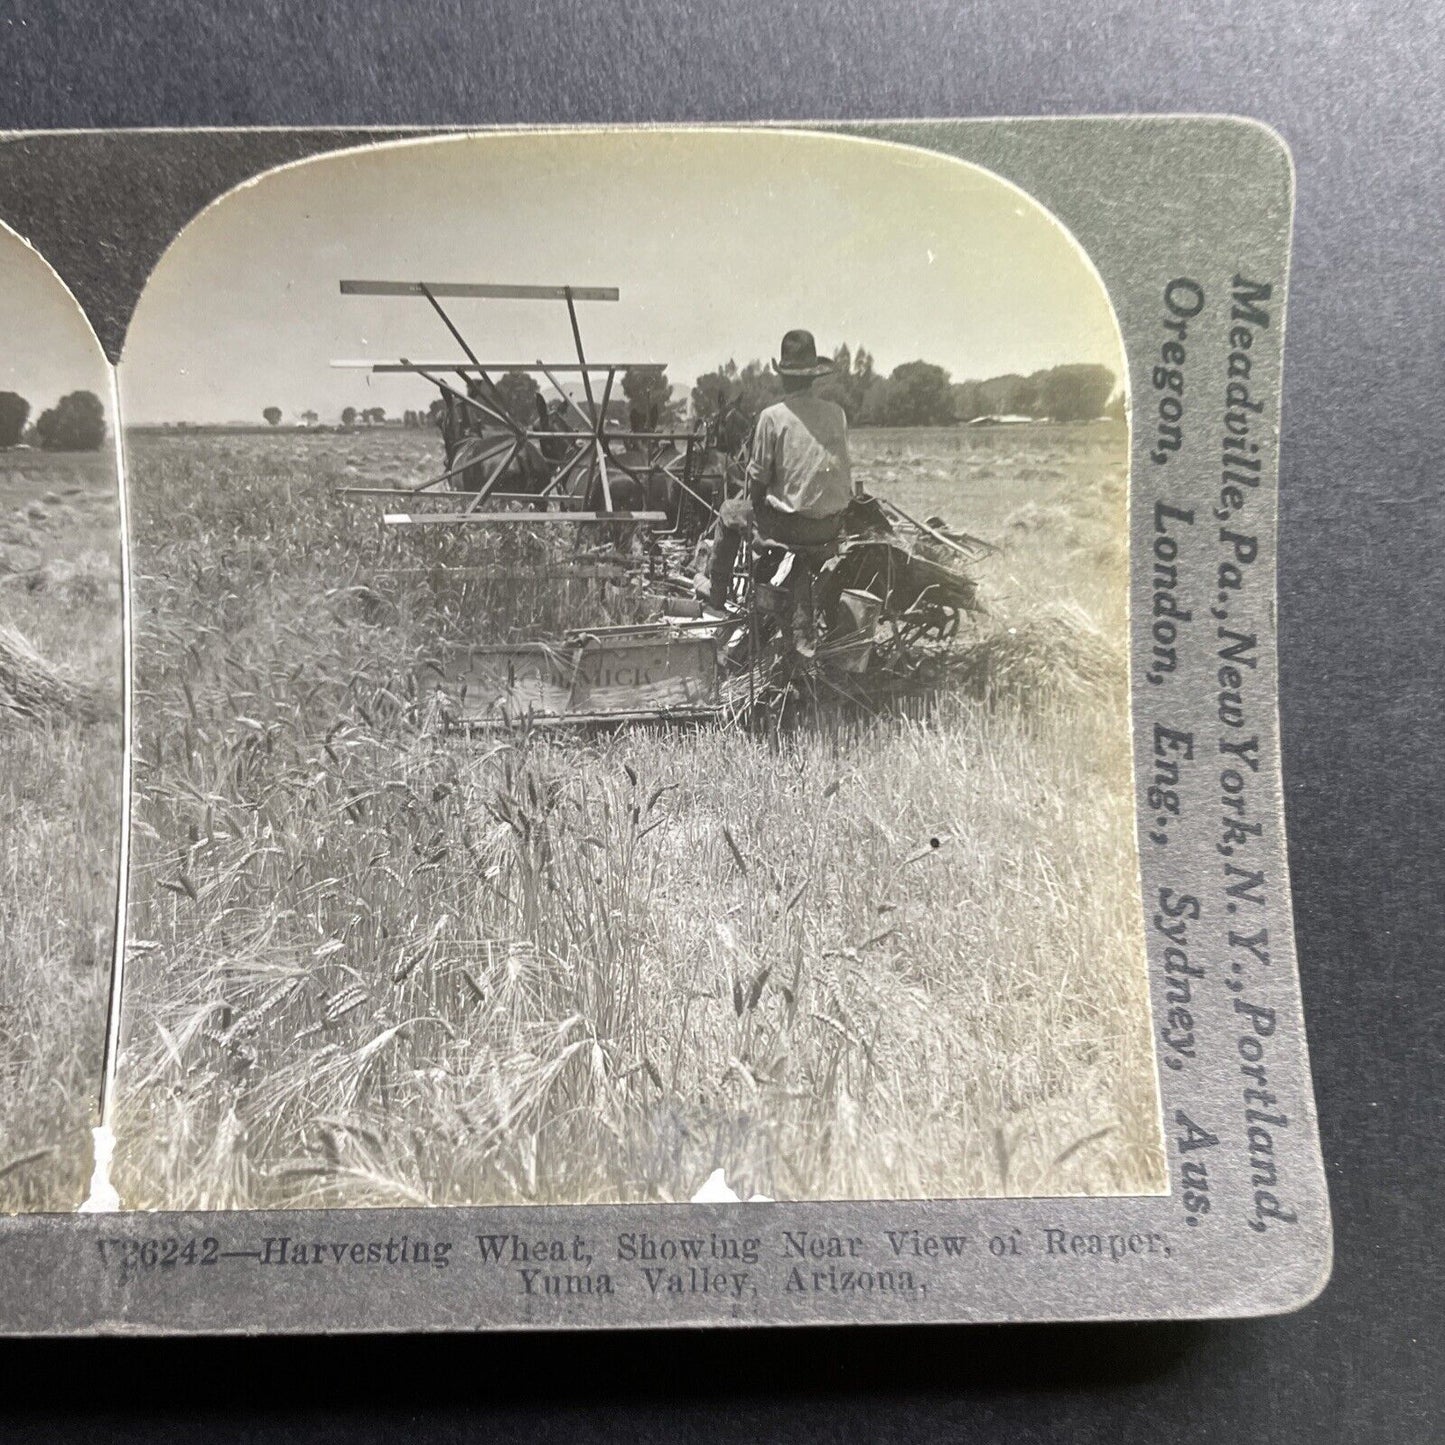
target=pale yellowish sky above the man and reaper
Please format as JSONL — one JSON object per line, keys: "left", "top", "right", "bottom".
{"left": 121, "top": 131, "right": 1123, "bottom": 422}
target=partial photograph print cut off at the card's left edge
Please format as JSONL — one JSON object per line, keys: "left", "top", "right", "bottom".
{"left": 0, "top": 227, "right": 123, "bottom": 1214}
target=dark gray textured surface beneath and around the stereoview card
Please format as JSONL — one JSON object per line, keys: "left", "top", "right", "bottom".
{"left": 0, "top": 0, "right": 1445, "bottom": 1445}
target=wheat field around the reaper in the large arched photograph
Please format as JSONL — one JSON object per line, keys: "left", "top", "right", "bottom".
{"left": 116, "top": 425, "right": 1163, "bottom": 1208}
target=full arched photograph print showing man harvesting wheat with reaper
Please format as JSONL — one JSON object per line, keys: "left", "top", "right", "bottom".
{"left": 114, "top": 130, "right": 1168, "bottom": 1209}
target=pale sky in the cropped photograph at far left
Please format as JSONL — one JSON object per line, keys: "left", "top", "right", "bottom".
{"left": 0, "top": 227, "right": 110, "bottom": 422}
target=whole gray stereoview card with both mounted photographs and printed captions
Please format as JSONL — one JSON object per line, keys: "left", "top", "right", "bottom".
{"left": 0, "top": 124, "right": 1331, "bottom": 1334}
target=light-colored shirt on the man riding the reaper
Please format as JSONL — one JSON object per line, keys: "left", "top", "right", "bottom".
{"left": 747, "top": 392, "right": 853, "bottom": 517}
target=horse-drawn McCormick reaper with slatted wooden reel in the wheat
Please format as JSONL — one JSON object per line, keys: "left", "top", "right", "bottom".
{"left": 337, "top": 280, "right": 993, "bottom": 728}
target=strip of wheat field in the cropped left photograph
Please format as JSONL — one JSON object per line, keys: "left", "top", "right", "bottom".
{"left": 0, "top": 449, "right": 121, "bottom": 1212}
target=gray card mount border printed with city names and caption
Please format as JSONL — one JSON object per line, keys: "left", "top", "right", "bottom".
{"left": 0, "top": 117, "right": 1331, "bottom": 1334}
